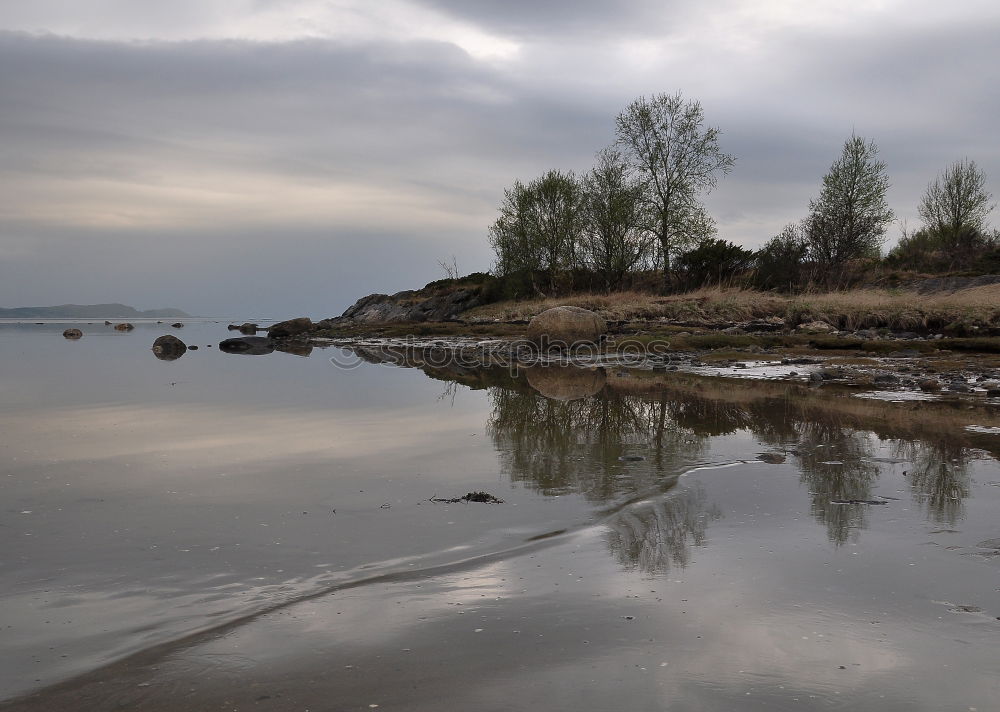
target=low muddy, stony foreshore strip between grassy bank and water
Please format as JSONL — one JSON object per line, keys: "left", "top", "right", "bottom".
{"left": 292, "top": 322, "right": 1000, "bottom": 405}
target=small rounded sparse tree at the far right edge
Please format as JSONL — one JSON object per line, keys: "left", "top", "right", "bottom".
{"left": 917, "top": 159, "right": 996, "bottom": 252}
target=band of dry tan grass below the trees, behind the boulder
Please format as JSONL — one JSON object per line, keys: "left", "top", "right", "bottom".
{"left": 463, "top": 285, "right": 1000, "bottom": 336}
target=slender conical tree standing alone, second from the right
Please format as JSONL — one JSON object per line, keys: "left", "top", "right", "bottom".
{"left": 805, "top": 136, "right": 893, "bottom": 279}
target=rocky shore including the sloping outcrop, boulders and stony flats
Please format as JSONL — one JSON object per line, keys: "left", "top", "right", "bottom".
{"left": 240, "top": 278, "right": 1000, "bottom": 402}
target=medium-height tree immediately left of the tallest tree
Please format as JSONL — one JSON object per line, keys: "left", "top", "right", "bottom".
{"left": 581, "top": 148, "right": 653, "bottom": 290}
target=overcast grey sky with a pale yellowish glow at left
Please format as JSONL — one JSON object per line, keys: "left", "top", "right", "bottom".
{"left": 0, "top": 0, "right": 1000, "bottom": 318}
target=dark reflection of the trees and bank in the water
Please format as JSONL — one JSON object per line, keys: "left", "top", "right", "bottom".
{"left": 338, "top": 340, "right": 1000, "bottom": 556}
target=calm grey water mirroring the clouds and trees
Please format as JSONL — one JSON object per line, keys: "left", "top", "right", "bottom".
{"left": 0, "top": 322, "right": 1000, "bottom": 710}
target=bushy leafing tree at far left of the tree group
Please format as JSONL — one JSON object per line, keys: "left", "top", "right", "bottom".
{"left": 490, "top": 170, "right": 582, "bottom": 296}
